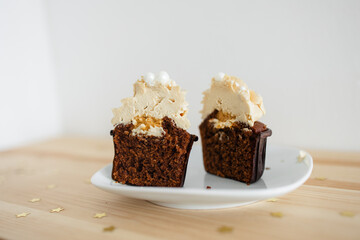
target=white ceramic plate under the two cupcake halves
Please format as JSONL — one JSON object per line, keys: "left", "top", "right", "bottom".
{"left": 91, "top": 144, "right": 313, "bottom": 209}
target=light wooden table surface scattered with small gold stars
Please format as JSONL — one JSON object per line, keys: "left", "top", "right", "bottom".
{"left": 0, "top": 138, "right": 360, "bottom": 240}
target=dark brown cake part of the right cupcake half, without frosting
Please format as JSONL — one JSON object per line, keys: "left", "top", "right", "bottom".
{"left": 199, "top": 110, "right": 271, "bottom": 184}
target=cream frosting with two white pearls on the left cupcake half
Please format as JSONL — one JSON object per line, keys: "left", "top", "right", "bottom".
{"left": 111, "top": 71, "right": 190, "bottom": 136}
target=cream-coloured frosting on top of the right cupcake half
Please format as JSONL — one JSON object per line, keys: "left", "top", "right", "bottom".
{"left": 201, "top": 73, "right": 265, "bottom": 128}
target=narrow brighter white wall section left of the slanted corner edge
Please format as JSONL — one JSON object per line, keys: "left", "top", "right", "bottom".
{"left": 0, "top": 0, "right": 61, "bottom": 150}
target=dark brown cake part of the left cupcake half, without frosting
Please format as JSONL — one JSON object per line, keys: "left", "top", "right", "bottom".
{"left": 111, "top": 117, "right": 198, "bottom": 187}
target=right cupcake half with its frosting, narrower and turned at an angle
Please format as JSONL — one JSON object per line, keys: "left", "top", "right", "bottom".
{"left": 199, "top": 73, "right": 272, "bottom": 184}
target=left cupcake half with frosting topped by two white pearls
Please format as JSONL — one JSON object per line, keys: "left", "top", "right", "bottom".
{"left": 111, "top": 72, "right": 197, "bottom": 187}
